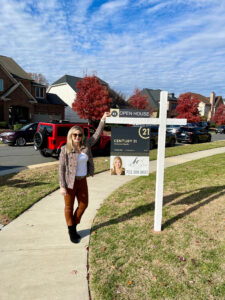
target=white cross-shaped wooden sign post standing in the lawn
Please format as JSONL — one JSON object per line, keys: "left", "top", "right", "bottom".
{"left": 106, "top": 91, "right": 187, "bottom": 231}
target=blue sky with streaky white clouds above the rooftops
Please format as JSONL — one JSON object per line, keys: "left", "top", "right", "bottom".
{"left": 0, "top": 0, "right": 225, "bottom": 97}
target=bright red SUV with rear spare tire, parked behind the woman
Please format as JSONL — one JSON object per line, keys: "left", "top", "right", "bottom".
{"left": 34, "top": 121, "right": 111, "bottom": 158}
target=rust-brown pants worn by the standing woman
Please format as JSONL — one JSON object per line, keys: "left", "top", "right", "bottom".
{"left": 64, "top": 177, "right": 88, "bottom": 226}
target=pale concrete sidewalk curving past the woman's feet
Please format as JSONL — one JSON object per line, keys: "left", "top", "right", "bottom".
{"left": 0, "top": 147, "right": 225, "bottom": 300}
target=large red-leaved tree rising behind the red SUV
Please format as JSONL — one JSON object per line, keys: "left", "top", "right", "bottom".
{"left": 72, "top": 75, "right": 112, "bottom": 123}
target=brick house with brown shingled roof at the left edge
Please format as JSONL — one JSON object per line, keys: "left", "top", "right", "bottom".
{"left": 0, "top": 56, "right": 66, "bottom": 124}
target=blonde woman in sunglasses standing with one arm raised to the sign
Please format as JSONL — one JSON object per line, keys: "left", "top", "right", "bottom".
{"left": 59, "top": 112, "right": 110, "bottom": 243}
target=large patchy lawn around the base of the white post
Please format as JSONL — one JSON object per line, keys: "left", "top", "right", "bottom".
{"left": 89, "top": 154, "right": 225, "bottom": 300}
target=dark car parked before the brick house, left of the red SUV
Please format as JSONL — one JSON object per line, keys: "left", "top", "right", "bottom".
{"left": 0, "top": 123, "right": 38, "bottom": 146}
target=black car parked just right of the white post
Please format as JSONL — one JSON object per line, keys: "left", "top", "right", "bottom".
{"left": 176, "top": 126, "right": 212, "bottom": 143}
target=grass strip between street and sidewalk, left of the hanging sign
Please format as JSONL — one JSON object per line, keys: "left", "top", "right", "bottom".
{"left": 0, "top": 157, "right": 109, "bottom": 225}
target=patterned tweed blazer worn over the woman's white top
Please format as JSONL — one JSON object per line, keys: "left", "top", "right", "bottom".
{"left": 59, "top": 121, "right": 105, "bottom": 189}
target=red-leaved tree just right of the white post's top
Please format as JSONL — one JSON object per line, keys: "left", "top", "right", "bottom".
{"left": 176, "top": 93, "right": 201, "bottom": 123}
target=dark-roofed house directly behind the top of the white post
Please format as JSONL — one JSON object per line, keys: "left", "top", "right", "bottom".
{"left": 141, "top": 88, "right": 177, "bottom": 118}
